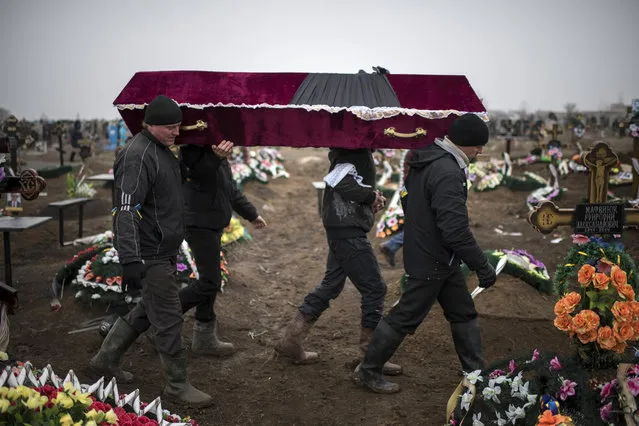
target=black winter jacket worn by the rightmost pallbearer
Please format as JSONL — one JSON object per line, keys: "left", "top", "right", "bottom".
{"left": 402, "top": 144, "right": 487, "bottom": 279}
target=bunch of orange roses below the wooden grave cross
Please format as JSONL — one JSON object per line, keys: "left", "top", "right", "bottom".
{"left": 554, "top": 258, "right": 639, "bottom": 368}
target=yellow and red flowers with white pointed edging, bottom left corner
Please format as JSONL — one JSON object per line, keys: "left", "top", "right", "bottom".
{"left": 0, "top": 362, "right": 197, "bottom": 426}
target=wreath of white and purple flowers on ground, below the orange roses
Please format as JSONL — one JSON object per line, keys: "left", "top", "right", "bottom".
{"left": 446, "top": 349, "right": 599, "bottom": 426}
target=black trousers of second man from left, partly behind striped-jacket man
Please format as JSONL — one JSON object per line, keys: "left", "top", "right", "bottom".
{"left": 180, "top": 227, "right": 222, "bottom": 322}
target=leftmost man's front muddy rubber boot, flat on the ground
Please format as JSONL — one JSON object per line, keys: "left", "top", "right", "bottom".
{"left": 160, "top": 349, "right": 213, "bottom": 408}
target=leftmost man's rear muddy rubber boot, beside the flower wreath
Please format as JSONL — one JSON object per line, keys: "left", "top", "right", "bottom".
{"left": 89, "top": 318, "right": 139, "bottom": 384}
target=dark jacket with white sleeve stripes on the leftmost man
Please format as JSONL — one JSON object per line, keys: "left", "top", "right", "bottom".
{"left": 113, "top": 130, "right": 184, "bottom": 264}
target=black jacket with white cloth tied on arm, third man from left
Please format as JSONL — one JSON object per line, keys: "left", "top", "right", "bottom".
{"left": 322, "top": 149, "right": 375, "bottom": 240}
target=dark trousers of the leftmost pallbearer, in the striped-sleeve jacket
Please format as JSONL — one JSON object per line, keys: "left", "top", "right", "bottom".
{"left": 124, "top": 259, "right": 183, "bottom": 355}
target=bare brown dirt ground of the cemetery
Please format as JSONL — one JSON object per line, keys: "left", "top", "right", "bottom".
{"left": 2, "top": 139, "right": 639, "bottom": 425}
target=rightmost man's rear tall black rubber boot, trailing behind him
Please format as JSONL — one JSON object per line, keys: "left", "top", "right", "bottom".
{"left": 353, "top": 320, "right": 404, "bottom": 393}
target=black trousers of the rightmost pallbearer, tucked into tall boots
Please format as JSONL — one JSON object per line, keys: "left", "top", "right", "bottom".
{"left": 385, "top": 267, "right": 477, "bottom": 334}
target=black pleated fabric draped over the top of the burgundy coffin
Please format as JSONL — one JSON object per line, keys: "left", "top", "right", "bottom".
{"left": 289, "top": 72, "right": 401, "bottom": 108}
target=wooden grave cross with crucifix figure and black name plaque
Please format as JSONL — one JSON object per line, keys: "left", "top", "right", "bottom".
{"left": 528, "top": 142, "right": 639, "bottom": 235}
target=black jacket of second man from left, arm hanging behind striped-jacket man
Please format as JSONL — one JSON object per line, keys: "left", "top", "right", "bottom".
{"left": 182, "top": 145, "right": 258, "bottom": 231}
